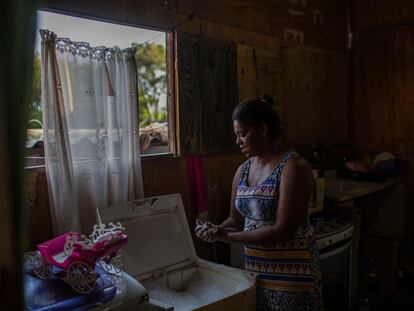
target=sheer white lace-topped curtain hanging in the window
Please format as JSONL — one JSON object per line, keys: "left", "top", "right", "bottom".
{"left": 40, "top": 30, "right": 143, "bottom": 234}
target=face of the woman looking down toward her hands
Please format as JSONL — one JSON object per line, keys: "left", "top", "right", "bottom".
{"left": 233, "top": 120, "right": 262, "bottom": 158}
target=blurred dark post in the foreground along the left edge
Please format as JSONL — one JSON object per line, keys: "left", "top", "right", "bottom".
{"left": 0, "top": 0, "right": 36, "bottom": 310}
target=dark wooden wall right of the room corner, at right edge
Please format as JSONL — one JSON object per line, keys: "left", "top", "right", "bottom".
{"left": 350, "top": 0, "right": 414, "bottom": 263}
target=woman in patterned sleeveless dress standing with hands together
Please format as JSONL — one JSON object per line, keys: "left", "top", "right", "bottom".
{"left": 195, "top": 95, "right": 322, "bottom": 311}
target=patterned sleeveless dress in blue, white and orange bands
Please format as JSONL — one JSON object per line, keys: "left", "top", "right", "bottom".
{"left": 236, "top": 151, "right": 323, "bottom": 311}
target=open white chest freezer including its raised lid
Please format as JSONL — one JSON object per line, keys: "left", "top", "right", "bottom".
{"left": 98, "top": 194, "right": 256, "bottom": 311}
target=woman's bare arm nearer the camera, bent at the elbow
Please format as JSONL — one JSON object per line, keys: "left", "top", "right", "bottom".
{"left": 216, "top": 158, "right": 314, "bottom": 245}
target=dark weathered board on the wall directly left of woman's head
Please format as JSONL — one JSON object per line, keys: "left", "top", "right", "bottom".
{"left": 198, "top": 39, "right": 239, "bottom": 155}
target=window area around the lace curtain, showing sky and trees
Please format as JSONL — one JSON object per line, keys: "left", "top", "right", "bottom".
{"left": 26, "top": 11, "right": 175, "bottom": 166}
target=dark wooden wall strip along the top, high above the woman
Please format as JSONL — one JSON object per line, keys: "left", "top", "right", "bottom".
{"left": 178, "top": 0, "right": 347, "bottom": 49}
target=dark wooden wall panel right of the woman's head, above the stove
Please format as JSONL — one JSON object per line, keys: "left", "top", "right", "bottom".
{"left": 282, "top": 48, "right": 349, "bottom": 145}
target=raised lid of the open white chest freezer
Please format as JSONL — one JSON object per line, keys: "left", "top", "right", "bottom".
{"left": 98, "top": 194, "right": 197, "bottom": 280}
